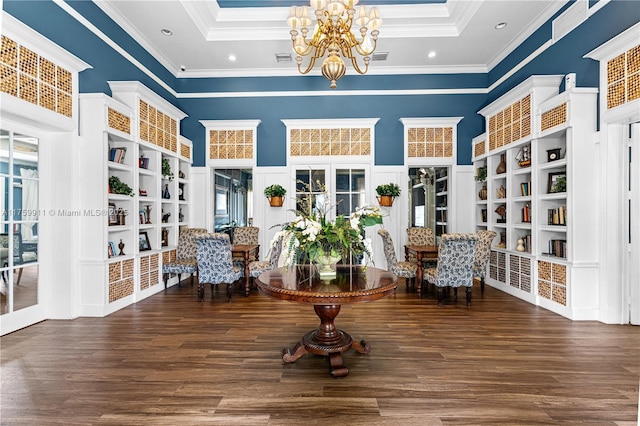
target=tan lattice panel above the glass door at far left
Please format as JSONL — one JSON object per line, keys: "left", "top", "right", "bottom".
{"left": 0, "top": 35, "right": 73, "bottom": 117}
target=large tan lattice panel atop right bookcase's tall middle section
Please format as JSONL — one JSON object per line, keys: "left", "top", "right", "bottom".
{"left": 488, "top": 95, "right": 531, "bottom": 151}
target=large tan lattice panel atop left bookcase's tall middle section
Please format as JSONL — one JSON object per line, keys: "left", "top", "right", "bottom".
{"left": 138, "top": 99, "right": 178, "bottom": 153}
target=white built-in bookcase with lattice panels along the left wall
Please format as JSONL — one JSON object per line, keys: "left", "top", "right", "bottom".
{"left": 79, "top": 82, "right": 190, "bottom": 316}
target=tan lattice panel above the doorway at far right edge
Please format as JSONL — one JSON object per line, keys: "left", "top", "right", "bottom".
{"left": 607, "top": 45, "right": 640, "bottom": 109}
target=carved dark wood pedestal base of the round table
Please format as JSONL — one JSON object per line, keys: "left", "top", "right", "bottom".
{"left": 282, "top": 305, "right": 371, "bottom": 377}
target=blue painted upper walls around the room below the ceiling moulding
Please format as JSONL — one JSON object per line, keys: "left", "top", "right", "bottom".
{"left": 3, "top": 0, "right": 640, "bottom": 166}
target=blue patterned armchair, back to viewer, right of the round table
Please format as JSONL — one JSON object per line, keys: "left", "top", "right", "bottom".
{"left": 423, "top": 234, "right": 478, "bottom": 306}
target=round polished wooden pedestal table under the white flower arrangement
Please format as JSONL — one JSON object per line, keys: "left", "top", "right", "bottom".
{"left": 256, "top": 265, "right": 398, "bottom": 377}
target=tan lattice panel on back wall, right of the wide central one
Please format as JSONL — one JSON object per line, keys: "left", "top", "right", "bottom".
{"left": 407, "top": 127, "right": 453, "bottom": 158}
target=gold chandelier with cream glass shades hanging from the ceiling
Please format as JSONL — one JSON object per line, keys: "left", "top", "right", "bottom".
{"left": 287, "top": 0, "right": 382, "bottom": 89}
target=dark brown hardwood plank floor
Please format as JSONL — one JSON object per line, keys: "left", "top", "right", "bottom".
{"left": 0, "top": 281, "right": 640, "bottom": 426}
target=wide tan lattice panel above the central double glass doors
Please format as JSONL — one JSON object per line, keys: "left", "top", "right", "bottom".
{"left": 289, "top": 127, "right": 371, "bottom": 157}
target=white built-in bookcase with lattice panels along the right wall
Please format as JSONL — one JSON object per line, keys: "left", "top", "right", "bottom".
{"left": 473, "top": 76, "right": 598, "bottom": 319}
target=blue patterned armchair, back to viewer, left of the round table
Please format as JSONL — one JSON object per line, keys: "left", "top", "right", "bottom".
{"left": 196, "top": 233, "right": 244, "bottom": 302}
